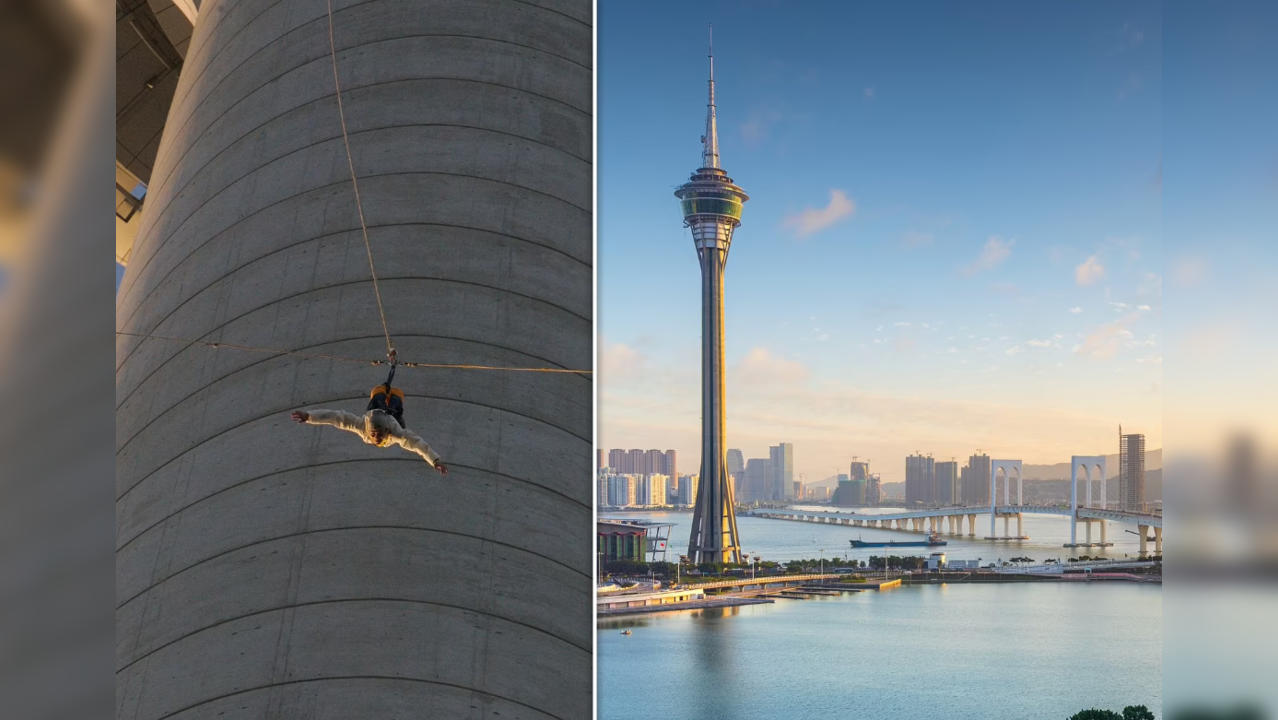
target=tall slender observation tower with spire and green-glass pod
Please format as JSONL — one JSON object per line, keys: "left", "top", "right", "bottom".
{"left": 675, "top": 36, "right": 749, "bottom": 563}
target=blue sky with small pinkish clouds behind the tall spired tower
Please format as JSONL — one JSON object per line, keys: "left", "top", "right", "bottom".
{"left": 598, "top": 3, "right": 1163, "bottom": 481}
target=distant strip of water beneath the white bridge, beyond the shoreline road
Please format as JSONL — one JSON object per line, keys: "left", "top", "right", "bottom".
{"left": 599, "top": 510, "right": 1154, "bottom": 561}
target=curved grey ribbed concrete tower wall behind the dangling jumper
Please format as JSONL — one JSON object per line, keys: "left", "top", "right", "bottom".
{"left": 116, "top": 0, "right": 593, "bottom": 720}
